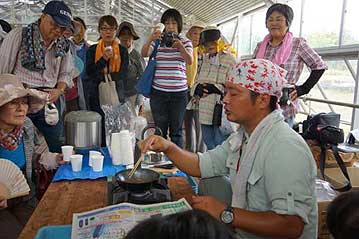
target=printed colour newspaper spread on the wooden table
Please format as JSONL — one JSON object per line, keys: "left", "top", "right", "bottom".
{"left": 71, "top": 198, "right": 192, "bottom": 239}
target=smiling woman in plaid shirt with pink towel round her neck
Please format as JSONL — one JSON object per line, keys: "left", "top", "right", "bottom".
{"left": 254, "top": 3, "right": 327, "bottom": 126}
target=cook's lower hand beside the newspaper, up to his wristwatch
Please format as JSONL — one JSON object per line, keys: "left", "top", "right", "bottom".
{"left": 192, "top": 196, "right": 226, "bottom": 220}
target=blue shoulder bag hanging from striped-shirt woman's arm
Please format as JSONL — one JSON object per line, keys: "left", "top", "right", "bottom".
{"left": 135, "top": 40, "right": 160, "bottom": 98}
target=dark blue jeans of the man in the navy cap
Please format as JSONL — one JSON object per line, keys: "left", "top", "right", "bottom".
{"left": 28, "top": 100, "right": 65, "bottom": 153}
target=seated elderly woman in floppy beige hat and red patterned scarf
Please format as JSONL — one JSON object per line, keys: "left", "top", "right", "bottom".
{"left": 0, "top": 74, "right": 63, "bottom": 238}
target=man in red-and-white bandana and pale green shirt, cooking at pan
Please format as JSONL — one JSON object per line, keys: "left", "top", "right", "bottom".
{"left": 140, "top": 59, "right": 317, "bottom": 238}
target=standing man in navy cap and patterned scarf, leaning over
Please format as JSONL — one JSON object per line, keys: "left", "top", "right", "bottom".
{"left": 0, "top": 1, "right": 73, "bottom": 152}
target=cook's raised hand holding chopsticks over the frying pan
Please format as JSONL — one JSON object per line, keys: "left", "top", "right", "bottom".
{"left": 138, "top": 135, "right": 173, "bottom": 153}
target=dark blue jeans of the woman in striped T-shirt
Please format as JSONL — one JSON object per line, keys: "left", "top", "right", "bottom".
{"left": 150, "top": 90, "right": 187, "bottom": 148}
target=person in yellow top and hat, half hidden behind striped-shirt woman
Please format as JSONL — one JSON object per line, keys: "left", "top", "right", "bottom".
{"left": 184, "top": 22, "right": 205, "bottom": 152}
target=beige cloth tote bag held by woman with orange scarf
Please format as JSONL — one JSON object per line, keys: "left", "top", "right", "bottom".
{"left": 98, "top": 74, "right": 120, "bottom": 106}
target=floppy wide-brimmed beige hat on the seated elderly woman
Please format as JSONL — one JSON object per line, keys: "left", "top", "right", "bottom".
{"left": 0, "top": 74, "right": 49, "bottom": 113}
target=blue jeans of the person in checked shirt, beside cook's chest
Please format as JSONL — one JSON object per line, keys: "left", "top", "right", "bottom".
{"left": 201, "top": 124, "right": 229, "bottom": 150}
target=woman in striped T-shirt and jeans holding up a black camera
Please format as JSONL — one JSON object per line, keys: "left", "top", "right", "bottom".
{"left": 141, "top": 9, "right": 193, "bottom": 148}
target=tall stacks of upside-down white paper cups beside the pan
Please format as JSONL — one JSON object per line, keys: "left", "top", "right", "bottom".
{"left": 111, "top": 130, "right": 133, "bottom": 165}
